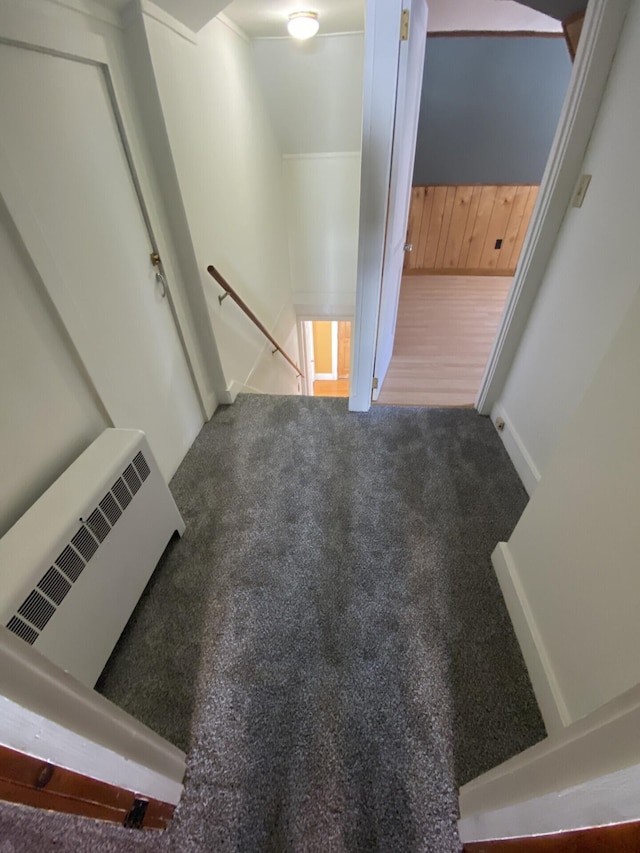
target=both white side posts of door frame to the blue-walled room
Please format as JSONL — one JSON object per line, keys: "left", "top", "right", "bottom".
{"left": 349, "top": 0, "right": 630, "bottom": 415}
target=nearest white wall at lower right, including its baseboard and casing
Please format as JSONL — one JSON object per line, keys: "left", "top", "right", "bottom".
{"left": 460, "top": 284, "right": 640, "bottom": 841}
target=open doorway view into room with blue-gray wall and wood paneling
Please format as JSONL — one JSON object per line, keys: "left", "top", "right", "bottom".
{"left": 376, "top": 24, "right": 571, "bottom": 406}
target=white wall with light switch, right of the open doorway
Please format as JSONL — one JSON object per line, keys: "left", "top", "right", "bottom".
{"left": 494, "top": 2, "right": 640, "bottom": 485}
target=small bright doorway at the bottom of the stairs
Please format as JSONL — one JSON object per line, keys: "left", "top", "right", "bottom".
{"left": 301, "top": 320, "right": 351, "bottom": 397}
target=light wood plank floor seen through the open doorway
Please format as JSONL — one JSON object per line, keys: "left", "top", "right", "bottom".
{"left": 377, "top": 275, "right": 511, "bottom": 406}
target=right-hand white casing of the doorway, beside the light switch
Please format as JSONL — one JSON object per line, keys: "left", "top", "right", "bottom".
{"left": 476, "top": 0, "right": 631, "bottom": 415}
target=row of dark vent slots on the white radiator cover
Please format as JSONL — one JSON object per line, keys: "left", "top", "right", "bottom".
{"left": 7, "top": 451, "right": 151, "bottom": 645}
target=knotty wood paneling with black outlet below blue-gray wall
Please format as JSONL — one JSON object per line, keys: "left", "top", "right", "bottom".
{"left": 404, "top": 185, "right": 538, "bottom": 275}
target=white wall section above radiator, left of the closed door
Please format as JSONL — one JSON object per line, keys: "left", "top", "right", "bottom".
{"left": 0, "top": 196, "right": 110, "bottom": 536}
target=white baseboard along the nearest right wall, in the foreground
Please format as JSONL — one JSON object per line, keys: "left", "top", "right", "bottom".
{"left": 491, "top": 542, "right": 572, "bottom": 735}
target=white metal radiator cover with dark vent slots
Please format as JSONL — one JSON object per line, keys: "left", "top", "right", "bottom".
{"left": 0, "top": 429, "right": 185, "bottom": 687}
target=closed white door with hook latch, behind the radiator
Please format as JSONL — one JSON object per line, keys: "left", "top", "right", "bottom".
{"left": 0, "top": 44, "right": 202, "bottom": 477}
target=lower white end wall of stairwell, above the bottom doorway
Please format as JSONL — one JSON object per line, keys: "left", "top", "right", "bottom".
{"left": 284, "top": 152, "right": 360, "bottom": 315}
